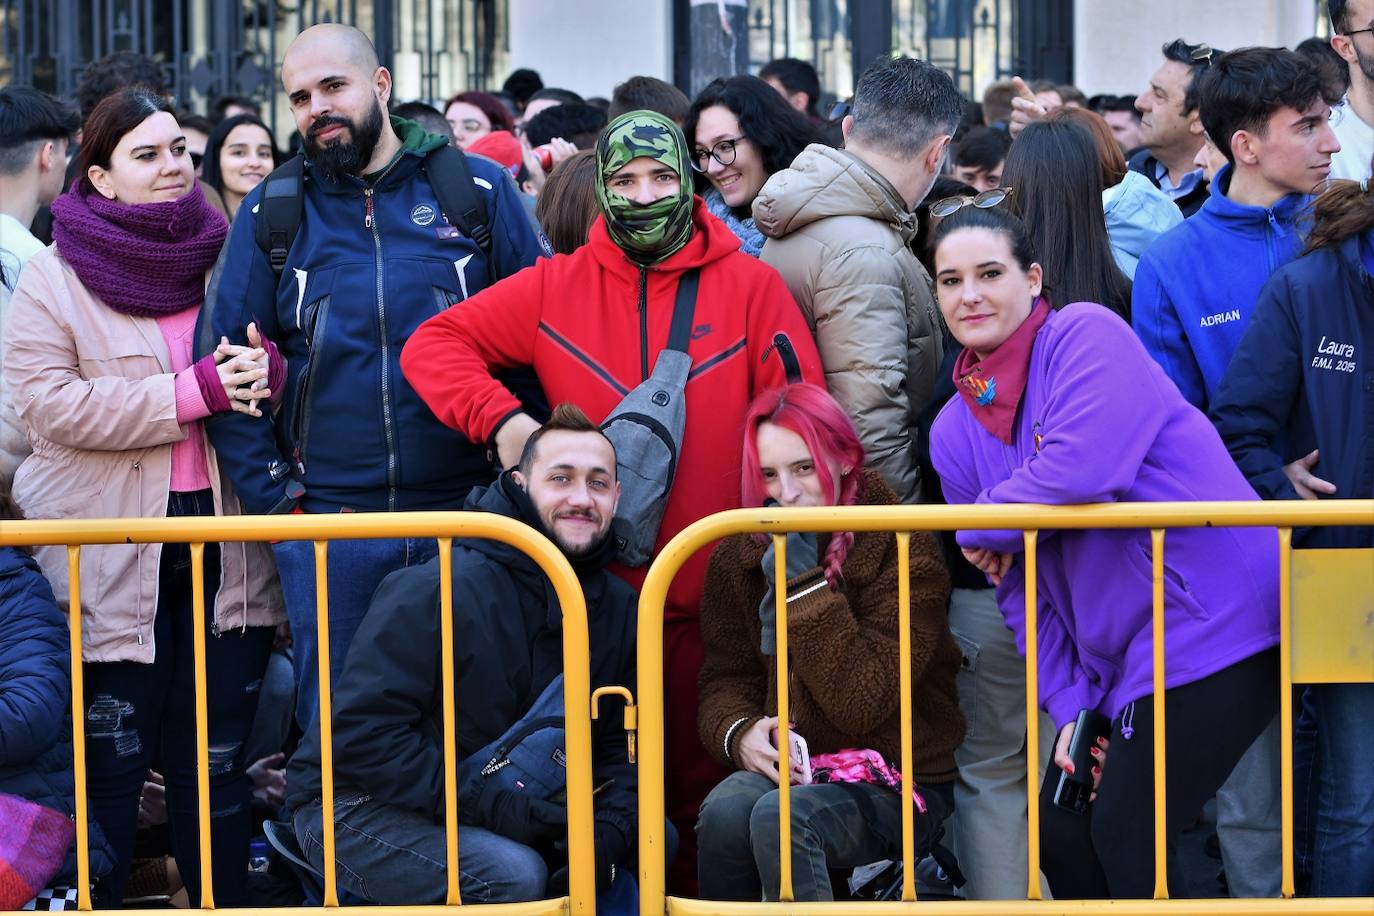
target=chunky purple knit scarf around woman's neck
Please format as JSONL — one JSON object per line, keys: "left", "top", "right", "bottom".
{"left": 52, "top": 179, "right": 229, "bottom": 319}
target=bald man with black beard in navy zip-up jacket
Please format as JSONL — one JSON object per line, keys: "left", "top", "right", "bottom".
{"left": 198, "top": 25, "right": 544, "bottom": 726}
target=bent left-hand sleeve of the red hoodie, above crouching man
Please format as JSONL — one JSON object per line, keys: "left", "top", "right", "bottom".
{"left": 401, "top": 260, "right": 550, "bottom": 442}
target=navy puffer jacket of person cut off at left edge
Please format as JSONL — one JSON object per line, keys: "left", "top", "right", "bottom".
{"left": 0, "top": 547, "right": 114, "bottom": 886}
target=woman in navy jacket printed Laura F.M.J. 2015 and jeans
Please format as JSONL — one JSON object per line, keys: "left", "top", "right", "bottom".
{"left": 1212, "top": 157, "right": 1374, "bottom": 897}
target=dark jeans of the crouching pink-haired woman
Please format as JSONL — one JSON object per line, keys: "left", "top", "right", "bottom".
{"left": 697, "top": 770, "right": 954, "bottom": 901}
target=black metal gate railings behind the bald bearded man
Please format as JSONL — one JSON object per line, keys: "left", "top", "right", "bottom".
{"left": 0, "top": 0, "right": 508, "bottom": 129}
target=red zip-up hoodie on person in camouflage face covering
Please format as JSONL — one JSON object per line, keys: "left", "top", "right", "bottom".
{"left": 401, "top": 199, "right": 824, "bottom": 619}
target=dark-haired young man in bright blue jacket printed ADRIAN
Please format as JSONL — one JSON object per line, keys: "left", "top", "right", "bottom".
{"left": 1131, "top": 48, "right": 1341, "bottom": 409}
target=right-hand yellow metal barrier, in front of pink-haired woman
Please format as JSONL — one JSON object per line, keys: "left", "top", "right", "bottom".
{"left": 638, "top": 500, "right": 1374, "bottom": 916}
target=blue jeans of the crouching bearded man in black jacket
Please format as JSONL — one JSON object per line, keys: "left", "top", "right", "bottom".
{"left": 295, "top": 792, "right": 548, "bottom": 905}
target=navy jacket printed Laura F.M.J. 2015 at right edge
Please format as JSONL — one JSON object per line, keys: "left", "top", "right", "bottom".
{"left": 1212, "top": 232, "right": 1374, "bottom": 548}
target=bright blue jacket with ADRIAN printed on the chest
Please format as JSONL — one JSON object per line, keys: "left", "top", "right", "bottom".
{"left": 1131, "top": 165, "right": 1311, "bottom": 411}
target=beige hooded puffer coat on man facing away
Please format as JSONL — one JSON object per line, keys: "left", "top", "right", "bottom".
{"left": 753, "top": 144, "right": 943, "bottom": 503}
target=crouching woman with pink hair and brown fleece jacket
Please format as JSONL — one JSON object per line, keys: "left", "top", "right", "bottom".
{"left": 697, "top": 385, "right": 963, "bottom": 901}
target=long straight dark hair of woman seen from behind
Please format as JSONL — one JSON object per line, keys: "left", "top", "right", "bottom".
{"left": 1002, "top": 121, "right": 1131, "bottom": 321}
